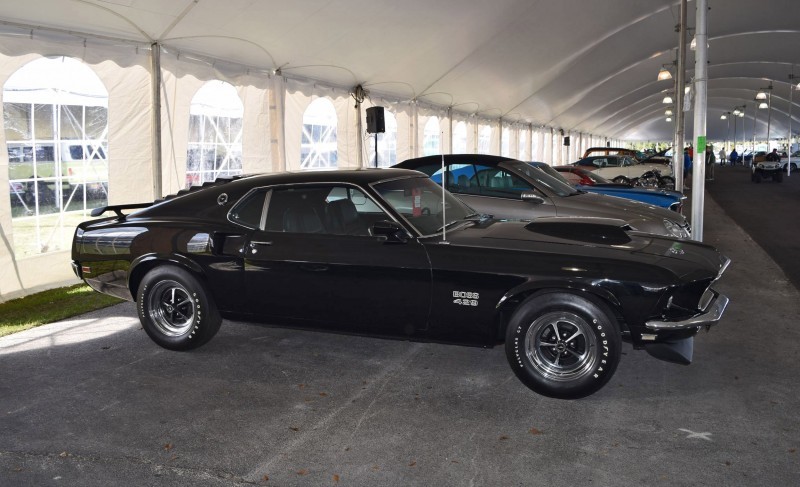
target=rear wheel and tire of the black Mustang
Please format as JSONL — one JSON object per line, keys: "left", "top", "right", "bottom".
{"left": 137, "top": 266, "right": 222, "bottom": 350}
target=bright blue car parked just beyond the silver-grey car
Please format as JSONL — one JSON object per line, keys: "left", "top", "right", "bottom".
{"left": 530, "top": 162, "right": 686, "bottom": 213}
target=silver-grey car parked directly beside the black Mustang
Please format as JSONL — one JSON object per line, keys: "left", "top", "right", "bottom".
{"left": 395, "top": 154, "right": 691, "bottom": 238}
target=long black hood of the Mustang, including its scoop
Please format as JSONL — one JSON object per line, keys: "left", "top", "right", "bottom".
{"left": 438, "top": 217, "right": 728, "bottom": 279}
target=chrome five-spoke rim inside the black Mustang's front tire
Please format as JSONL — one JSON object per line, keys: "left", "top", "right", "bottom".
{"left": 524, "top": 312, "right": 598, "bottom": 382}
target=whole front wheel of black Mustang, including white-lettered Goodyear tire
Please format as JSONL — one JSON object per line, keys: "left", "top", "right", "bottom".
{"left": 506, "top": 293, "right": 622, "bottom": 399}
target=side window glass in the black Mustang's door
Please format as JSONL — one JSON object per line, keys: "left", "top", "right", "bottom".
{"left": 264, "top": 185, "right": 388, "bottom": 236}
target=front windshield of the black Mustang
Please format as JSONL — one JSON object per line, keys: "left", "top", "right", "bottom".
{"left": 372, "top": 177, "right": 475, "bottom": 236}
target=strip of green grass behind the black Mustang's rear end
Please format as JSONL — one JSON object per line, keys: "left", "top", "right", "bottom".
{"left": 0, "top": 284, "right": 122, "bottom": 336}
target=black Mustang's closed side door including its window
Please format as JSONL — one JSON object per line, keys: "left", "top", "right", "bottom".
{"left": 231, "top": 184, "right": 431, "bottom": 335}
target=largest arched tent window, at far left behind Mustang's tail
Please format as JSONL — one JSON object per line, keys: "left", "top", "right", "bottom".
{"left": 3, "top": 56, "right": 108, "bottom": 258}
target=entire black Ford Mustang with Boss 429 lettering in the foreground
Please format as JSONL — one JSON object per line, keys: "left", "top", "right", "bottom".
{"left": 72, "top": 169, "right": 729, "bottom": 398}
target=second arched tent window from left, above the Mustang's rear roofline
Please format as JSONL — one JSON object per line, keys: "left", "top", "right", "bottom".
{"left": 186, "top": 81, "right": 244, "bottom": 187}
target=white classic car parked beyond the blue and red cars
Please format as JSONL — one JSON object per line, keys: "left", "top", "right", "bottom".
{"left": 572, "top": 155, "right": 675, "bottom": 189}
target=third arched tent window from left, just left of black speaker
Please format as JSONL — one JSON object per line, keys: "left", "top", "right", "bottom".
{"left": 300, "top": 98, "right": 337, "bottom": 169}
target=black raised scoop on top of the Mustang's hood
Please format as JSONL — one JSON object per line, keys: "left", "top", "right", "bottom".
{"left": 525, "top": 217, "right": 633, "bottom": 245}
